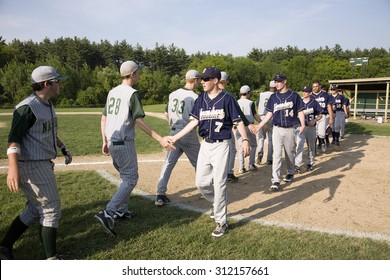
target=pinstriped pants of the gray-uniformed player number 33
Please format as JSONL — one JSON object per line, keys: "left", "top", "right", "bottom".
{"left": 157, "top": 130, "right": 200, "bottom": 195}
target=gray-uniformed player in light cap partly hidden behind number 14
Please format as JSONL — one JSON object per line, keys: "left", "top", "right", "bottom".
{"left": 256, "top": 81, "right": 275, "bottom": 165}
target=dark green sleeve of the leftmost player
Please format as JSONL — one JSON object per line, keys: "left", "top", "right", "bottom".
{"left": 8, "top": 105, "right": 36, "bottom": 145}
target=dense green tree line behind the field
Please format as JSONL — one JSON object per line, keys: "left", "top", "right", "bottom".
{"left": 0, "top": 36, "right": 390, "bottom": 108}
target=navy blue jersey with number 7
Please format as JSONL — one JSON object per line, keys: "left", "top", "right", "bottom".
{"left": 190, "top": 91, "right": 242, "bottom": 140}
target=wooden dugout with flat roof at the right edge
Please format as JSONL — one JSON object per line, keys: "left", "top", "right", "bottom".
{"left": 329, "top": 77, "right": 390, "bottom": 122}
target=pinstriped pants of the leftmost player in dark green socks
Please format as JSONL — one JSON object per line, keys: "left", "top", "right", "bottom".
{"left": 19, "top": 160, "right": 61, "bottom": 228}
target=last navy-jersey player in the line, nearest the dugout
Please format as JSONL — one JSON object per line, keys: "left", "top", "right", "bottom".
{"left": 331, "top": 85, "right": 348, "bottom": 146}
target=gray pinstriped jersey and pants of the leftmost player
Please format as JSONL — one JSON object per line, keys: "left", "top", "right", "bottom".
{"left": 8, "top": 93, "right": 61, "bottom": 228}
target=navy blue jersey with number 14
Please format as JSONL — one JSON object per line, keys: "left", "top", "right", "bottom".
{"left": 265, "top": 89, "right": 305, "bottom": 127}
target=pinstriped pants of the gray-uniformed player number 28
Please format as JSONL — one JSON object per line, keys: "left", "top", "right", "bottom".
{"left": 106, "top": 139, "right": 138, "bottom": 214}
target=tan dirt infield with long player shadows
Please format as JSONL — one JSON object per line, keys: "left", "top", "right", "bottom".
{"left": 0, "top": 135, "right": 390, "bottom": 241}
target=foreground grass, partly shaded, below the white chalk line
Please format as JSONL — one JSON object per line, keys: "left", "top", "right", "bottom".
{"left": 0, "top": 171, "right": 390, "bottom": 260}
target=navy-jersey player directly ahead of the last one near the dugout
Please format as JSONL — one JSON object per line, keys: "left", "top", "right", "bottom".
{"left": 311, "top": 82, "right": 333, "bottom": 153}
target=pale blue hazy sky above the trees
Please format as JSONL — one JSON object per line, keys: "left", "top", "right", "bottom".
{"left": 0, "top": 0, "right": 390, "bottom": 56}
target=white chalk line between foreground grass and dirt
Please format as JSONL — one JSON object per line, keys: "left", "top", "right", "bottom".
{"left": 97, "top": 170, "right": 390, "bottom": 242}
